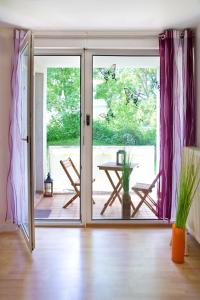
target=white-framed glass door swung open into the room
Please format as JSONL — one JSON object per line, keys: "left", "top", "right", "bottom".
{"left": 19, "top": 33, "right": 34, "bottom": 251}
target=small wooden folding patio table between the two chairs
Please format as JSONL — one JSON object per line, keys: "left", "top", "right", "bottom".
{"left": 97, "top": 162, "right": 138, "bottom": 215}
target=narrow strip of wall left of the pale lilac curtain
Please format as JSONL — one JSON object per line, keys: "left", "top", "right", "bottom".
{"left": 0, "top": 28, "right": 13, "bottom": 229}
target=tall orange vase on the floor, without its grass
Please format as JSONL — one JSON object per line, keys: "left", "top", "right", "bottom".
{"left": 172, "top": 224, "right": 185, "bottom": 264}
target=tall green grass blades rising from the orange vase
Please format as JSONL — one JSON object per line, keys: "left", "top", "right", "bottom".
{"left": 176, "top": 153, "right": 200, "bottom": 228}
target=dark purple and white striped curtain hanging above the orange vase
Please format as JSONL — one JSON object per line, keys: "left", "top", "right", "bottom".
{"left": 158, "top": 29, "right": 196, "bottom": 220}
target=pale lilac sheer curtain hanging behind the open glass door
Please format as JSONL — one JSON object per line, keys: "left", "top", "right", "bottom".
{"left": 6, "top": 29, "right": 26, "bottom": 224}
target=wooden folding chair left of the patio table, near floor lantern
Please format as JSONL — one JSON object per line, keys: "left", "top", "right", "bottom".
{"left": 60, "top": 157, "right": 95, "bottom": 208}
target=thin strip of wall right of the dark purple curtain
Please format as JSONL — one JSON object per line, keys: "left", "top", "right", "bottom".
{"left": 196, "top": 24, "right": 200, "bottom": 147}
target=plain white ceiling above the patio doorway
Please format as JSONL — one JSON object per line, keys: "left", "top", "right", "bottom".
{"left": 0, "top": 0, "right": 200, "bottom": 31}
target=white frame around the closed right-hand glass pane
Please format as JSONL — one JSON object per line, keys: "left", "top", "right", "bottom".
{"left": 84, "top": 49, "right": 160, "bottom": 224}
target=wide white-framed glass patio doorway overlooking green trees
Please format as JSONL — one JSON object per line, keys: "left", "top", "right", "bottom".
{"left": 34, "top": 49, "right": 159, "bottom": 225}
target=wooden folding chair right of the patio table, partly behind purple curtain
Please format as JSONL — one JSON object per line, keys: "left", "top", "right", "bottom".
{"left": 131, "top": 172, "right": 161, "bottom": 218}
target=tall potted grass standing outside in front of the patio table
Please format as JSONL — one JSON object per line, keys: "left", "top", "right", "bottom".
{"left": 122, "top": 156, "right": 132, "bottom": 219}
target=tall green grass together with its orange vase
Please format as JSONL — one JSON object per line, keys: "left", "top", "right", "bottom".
{"left": 172, "top": 152, "right": 200, "bottom": 263}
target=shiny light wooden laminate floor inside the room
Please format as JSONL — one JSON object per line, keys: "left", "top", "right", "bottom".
{"left": 0, "top": 228, "right": 200, "bottom": 300}
